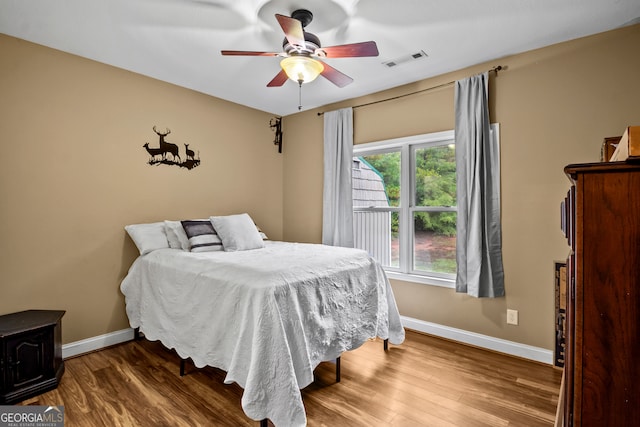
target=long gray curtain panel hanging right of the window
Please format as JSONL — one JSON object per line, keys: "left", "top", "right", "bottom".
{"left": 455, "top": 72, "right": 504, "bottom": 297}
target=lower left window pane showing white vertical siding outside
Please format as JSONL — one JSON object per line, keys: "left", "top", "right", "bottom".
{"left": 353, "top": 211, "right": 400, "bottom": 267}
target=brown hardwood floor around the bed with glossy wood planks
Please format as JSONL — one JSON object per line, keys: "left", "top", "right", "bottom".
{"left": 21, "top": 331, "right": 561, "bottom": 427}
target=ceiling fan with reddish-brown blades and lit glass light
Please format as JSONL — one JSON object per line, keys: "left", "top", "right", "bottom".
{"left": 221, "top": 9, "right": 378, "bottom": 87}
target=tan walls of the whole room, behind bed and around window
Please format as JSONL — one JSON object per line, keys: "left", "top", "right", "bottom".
{"left": 0, "top": 21, "right": 640, "bottom": 349}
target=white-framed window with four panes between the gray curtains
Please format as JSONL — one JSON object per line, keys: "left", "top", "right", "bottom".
{"left": 352, "top": 131, "right": 457, "bottom": 287}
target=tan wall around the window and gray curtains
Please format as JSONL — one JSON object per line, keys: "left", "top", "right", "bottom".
{"left": 283, "top": 25, "right": 640, "bottom": 349}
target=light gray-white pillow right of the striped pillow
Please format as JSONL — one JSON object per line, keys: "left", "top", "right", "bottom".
{"left": 210, "top": 213, "right": 264, "bottom": 252}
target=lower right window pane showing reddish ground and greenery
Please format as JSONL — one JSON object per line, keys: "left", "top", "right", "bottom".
{"left": 413, "top": 212, "right": 457, "bottom": 274}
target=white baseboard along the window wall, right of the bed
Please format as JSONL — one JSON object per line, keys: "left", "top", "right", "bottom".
{"left": 400, "top": 316, "right": 553, "bottom": 365}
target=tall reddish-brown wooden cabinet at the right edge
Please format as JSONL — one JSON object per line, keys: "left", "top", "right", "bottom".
{"left": 556, "top": 162, "right": 640, "bottom": 427}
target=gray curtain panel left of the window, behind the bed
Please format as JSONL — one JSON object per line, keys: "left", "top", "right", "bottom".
{"left": 322, "top": 108, "right": 353, "bottom": 248}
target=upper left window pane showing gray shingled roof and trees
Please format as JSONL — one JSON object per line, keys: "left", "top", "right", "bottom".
{"left": 352, "top": 151, "right": 400, "bottom": 207}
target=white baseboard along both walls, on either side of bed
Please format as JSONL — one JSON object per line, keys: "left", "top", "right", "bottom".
{"left": 62, "top": 322, "right": 553, "bottom": 365}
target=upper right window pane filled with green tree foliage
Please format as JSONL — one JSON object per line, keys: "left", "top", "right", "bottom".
{"left": 415, "top": 144, "right": 456, "bottom": 206}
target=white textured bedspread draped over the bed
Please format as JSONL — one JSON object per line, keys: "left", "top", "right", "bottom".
{"left": 120, "top": 242, "right": 404, "bottom": 426}
